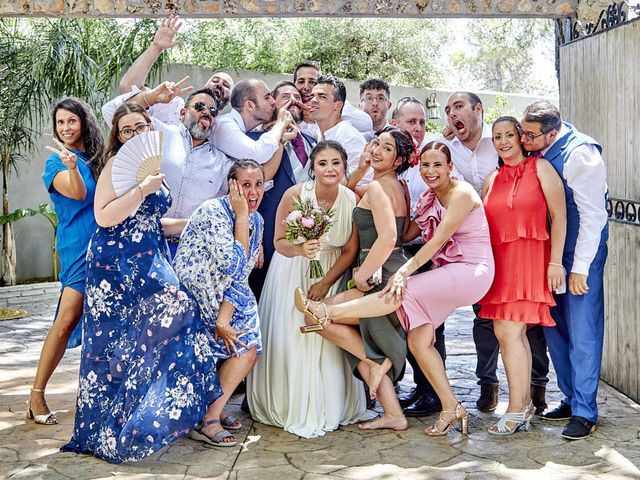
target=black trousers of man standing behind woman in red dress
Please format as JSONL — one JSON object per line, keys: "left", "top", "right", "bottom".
{"left": 473, "top": 304, "right": 549, "bottom": 387}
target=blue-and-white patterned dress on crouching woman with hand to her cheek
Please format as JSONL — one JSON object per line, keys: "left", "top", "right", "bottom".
{"left": 173, "top": 196, "right": 263, "bottom": 358}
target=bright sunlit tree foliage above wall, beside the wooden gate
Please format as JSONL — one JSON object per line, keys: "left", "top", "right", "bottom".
{"left": 451, "top": 18, "right": 553, "bottom": 95}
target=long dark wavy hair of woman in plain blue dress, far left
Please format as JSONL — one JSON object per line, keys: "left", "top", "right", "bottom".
{"left": 51, "top": 97, "right": 104, "bottom": 178}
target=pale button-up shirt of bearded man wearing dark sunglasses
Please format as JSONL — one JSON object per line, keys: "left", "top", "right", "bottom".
{"left": 102, "top": 93, "right": 233, "bottom": 218}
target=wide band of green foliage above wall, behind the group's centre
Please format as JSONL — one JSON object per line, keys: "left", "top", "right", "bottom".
{"left": 172, "top": 18, "right": 448, "bottom": 87}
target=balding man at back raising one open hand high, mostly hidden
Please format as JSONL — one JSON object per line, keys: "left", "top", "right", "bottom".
{"left": 120, "top": 15, "right": 234, "bottom": 125}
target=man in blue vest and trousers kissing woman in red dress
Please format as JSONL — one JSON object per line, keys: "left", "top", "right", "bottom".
{"left": 521, "top": 100, "right": 608, "bottom": 440}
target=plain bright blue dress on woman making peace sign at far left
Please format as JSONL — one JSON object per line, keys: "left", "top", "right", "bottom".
{"left": 42, "top": 150, "right": 97, "bottom": 348}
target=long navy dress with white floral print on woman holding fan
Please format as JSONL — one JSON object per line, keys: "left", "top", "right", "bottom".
{"left": 62, "top": 191, "right": 222, "bottom": 463}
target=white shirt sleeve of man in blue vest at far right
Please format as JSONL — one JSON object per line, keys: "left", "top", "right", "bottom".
{"left": 563, "top": 145, "right": 607, "bottom": 275}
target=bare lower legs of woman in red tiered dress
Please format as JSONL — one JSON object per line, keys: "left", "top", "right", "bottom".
{"left": 493, "top": 320, "right": 531, "bottom": 428}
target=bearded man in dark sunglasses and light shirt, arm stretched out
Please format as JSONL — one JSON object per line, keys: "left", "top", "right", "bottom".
{"left": 102, "top": 77, "right": 232, "bottom": 255}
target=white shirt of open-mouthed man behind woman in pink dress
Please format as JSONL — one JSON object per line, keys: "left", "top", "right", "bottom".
{"left": 437, "top": 124, "right": 498, "bottom": 194}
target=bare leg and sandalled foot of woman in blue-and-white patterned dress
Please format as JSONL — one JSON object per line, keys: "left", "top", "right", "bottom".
{"left": 202, "top": 347, "right": 259, "bottom": 442}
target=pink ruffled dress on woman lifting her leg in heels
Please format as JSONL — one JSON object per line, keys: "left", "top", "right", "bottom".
{"left": 398, "top": 189, "right": 494, "bottom": 338}
